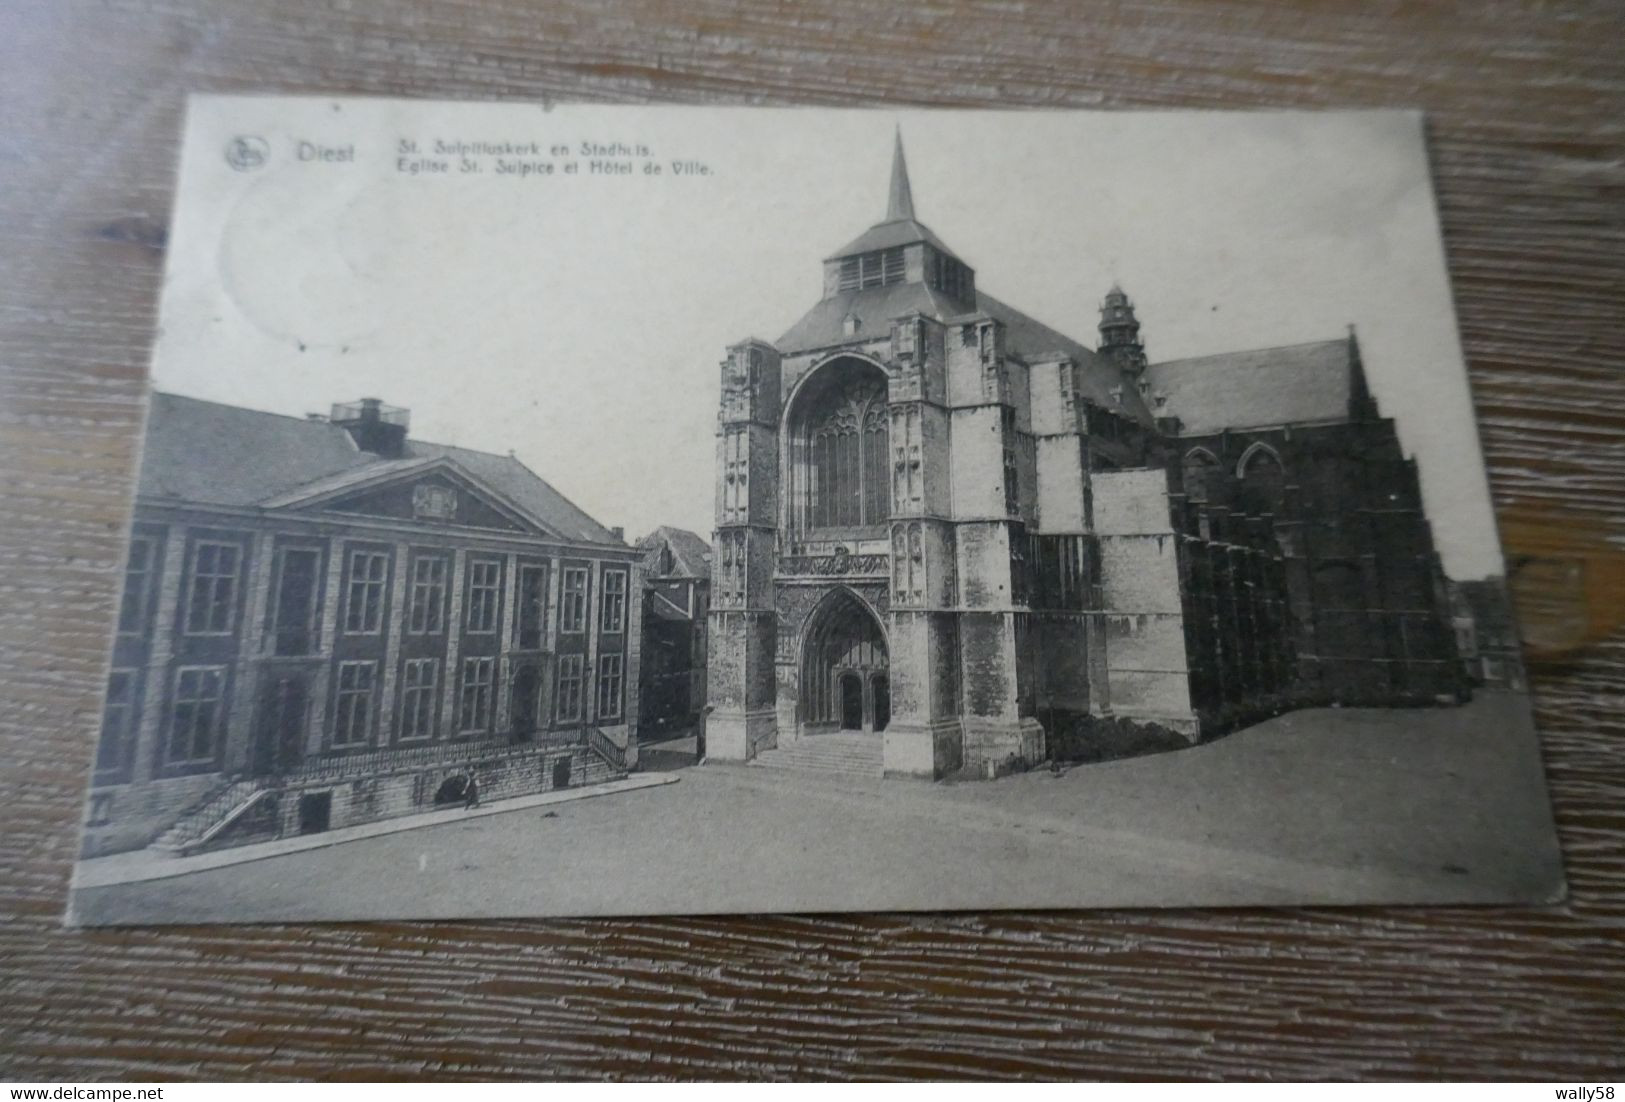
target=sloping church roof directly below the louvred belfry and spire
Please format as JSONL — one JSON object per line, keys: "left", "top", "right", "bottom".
{"left": 775, "top": 283, "right": 1152, "bottom": 424}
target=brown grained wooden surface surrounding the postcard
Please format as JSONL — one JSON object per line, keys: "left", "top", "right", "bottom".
{"left": 0, "top": 0, "right": 1625, "bottom": 1081}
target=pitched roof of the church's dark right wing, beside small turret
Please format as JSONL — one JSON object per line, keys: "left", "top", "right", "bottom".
{"left": 1146, "top": 340, "right": 1357, "bottom": 434}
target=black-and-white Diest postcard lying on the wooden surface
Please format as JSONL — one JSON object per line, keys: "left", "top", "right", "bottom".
{"left": 68, "top": 96, "right": 1563, "bottom": 925}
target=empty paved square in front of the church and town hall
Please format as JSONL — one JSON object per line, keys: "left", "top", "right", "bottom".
{"left": 76, "top": 694, "right": 1560, "bottom": 923}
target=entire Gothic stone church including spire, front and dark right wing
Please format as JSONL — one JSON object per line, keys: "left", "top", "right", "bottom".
{"left": 707, "top": 140, "right": 1461, "bottom": 779}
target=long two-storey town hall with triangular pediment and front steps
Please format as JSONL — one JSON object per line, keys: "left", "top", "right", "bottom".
{"left": 85, "top": 393, "right": 642, "bottom": 857}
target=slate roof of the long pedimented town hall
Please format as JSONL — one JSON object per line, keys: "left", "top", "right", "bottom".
{"left": 137, "top": 393, "right": 621, "bottom": 543}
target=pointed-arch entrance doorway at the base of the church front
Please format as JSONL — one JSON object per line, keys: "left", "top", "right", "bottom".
{"left": 800, "top": 590, "right": 891, "bottom": 735}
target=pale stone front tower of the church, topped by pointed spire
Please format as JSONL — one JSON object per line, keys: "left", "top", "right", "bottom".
{"left": 705, "top": 135, "right": 1046, "bottom": 779}
